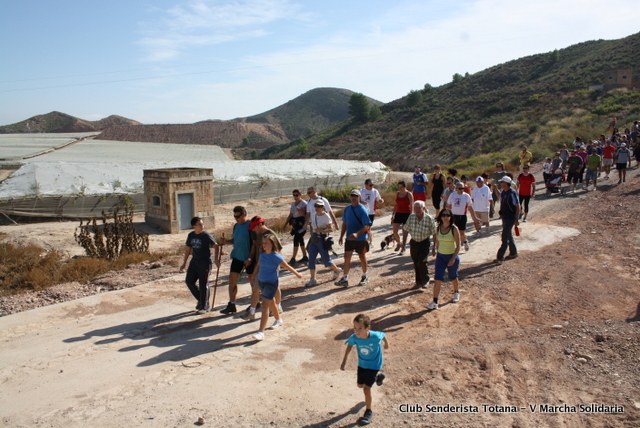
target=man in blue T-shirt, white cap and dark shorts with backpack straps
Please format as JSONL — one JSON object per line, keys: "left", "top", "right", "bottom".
{"left": 335, "top": 189, "right": 371, "bottom": 287}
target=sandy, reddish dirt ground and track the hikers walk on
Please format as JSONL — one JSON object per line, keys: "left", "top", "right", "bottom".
{"left": 0, "top": 170, "right": 640, "bottom": 427}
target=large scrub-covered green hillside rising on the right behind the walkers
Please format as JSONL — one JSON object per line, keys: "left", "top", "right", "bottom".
{"left": 262, "top": 33, "right": 640, "bottom": 168}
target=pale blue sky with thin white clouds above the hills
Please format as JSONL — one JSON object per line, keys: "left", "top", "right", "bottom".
{"left": 0, "top": 0, "right": 640, "bottom": 125}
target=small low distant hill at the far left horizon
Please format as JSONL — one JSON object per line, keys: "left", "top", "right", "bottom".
{"left": 0, "top": 111, "right": 140, "bottom": 134}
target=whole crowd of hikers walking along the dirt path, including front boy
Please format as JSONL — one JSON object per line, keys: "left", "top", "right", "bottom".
{"left": 180, "top": 122, "right": 640, "bottom": 425}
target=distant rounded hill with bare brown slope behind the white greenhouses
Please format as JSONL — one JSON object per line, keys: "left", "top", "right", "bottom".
{"left": 99, "top": 88, "right": 381, "bottom": 153}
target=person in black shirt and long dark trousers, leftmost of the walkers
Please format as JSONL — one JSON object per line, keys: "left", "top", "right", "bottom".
{"left": 180, "top": 217, "right": 220, "bottom": 314}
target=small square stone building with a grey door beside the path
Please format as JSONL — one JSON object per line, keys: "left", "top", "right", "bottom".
{"left": 144, "top": 168, "right": 215, "bottom": 233}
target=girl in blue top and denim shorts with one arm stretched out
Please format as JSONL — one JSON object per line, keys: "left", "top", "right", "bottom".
{"left": 253, "top": 233, "right": 302, "bottom": 340}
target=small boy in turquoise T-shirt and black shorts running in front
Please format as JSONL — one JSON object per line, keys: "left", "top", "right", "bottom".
{"left": 340, "top": 314, "right": 389, "bottom": 425}
